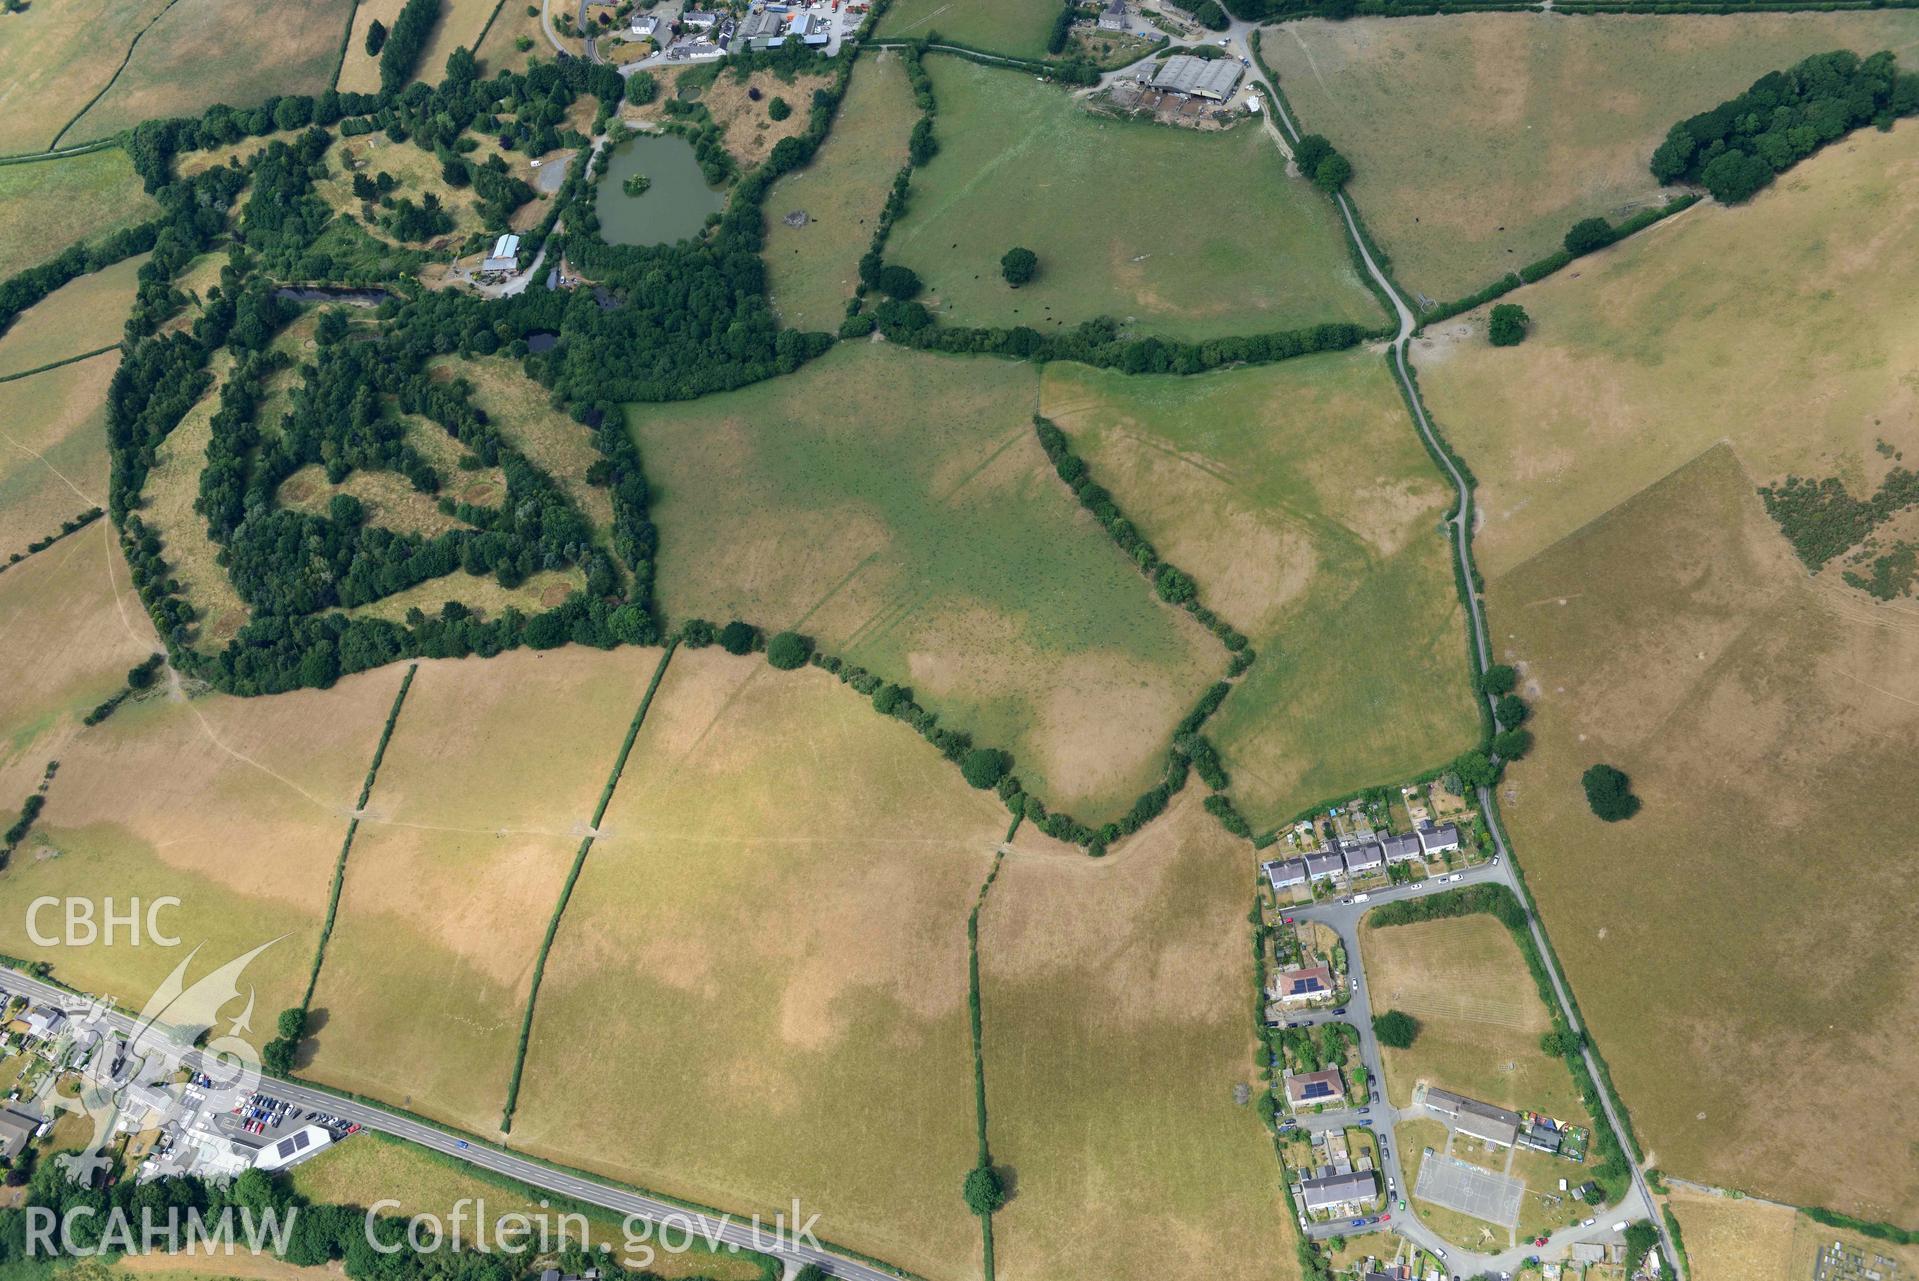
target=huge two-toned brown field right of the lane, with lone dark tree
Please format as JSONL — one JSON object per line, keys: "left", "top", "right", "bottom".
{"left": 1416, "top": 123, "right": 1919, "bottom": 1222}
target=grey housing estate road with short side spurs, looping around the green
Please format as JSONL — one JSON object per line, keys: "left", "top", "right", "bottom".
{"left": 1280, "top": 855, "right": 1652, "bottom": 1277}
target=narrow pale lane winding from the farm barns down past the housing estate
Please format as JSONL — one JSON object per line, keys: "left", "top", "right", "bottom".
{"left": 1230, "top": 21, "right": 1687, "bottom": 1281}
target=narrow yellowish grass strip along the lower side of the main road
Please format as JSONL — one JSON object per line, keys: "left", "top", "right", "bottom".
{"left": 290, "top": 1133, "right": 760, "bottom": 1281}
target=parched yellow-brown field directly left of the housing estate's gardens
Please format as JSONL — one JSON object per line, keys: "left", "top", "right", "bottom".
{"left": 979, "top": 794, "right": 1299, "bottom": 1281}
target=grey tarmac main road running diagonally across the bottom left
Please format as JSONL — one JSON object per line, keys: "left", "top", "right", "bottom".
{"left": 0, "top": 967, "right": 890, "bottom": 1281}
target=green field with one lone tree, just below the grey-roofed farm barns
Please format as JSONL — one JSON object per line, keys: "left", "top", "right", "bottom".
{"left": 887, "top": 58, "right": 1384, "bottom": 339}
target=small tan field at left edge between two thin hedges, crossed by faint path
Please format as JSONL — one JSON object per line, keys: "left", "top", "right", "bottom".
{"left": 0, "top": 353, "right": 119, "bottom": 564}
